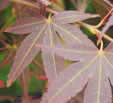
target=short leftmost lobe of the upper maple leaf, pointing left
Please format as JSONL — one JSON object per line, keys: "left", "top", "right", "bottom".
{"left": 5, "top": 17, "right": 44, "bottom": 34}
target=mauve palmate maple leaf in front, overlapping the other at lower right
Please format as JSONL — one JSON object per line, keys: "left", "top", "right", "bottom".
{"left": 38, "top": 43, "right": 113, "bottom": 103}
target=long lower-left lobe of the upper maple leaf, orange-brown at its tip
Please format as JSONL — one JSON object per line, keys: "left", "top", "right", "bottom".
{"left": 7, "top": 23, "right": 46, "bottom": 86}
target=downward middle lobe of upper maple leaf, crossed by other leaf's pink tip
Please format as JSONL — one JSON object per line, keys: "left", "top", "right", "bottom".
{"left": 42, "top": 24, "right": 64, "bottom": 83}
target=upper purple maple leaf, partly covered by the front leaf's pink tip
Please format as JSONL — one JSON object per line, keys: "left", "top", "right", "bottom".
{"left": 6, "top": 11, "right": 91, "bottom": 86}
